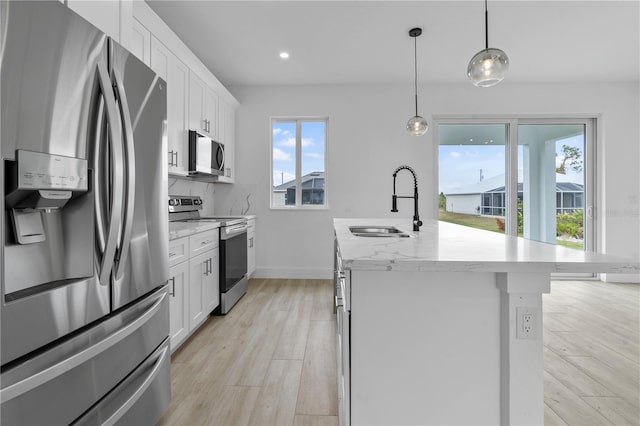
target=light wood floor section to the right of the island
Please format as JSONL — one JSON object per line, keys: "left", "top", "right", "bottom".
{"left": 543, "top": 281, "right": 640, "bottom": 425}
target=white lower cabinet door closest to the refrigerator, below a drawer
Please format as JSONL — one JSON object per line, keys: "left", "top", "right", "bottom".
{"left": 169, "top": 262, "right": 189, "bottom": 352}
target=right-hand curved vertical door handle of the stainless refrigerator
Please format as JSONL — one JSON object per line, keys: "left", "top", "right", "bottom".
{"left": 113, "top": 71, "right": 136, "bottom": 280}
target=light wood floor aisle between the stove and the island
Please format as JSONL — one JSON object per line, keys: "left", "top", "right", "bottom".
{"left": 159, "top": 279, "right": 338, "bottom": 426}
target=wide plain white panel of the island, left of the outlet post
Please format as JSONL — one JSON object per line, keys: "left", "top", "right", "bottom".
{"left": 351, "top": 270, "right": 500, "bottom": 425}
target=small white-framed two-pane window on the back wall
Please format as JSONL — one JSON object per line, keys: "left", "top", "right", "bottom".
{"left": 271, "top": 118, "right": 327, "bottom": 209}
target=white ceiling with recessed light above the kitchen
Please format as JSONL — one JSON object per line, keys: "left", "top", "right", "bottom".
{"left": 146, "top": 0, "right": 640, "bottom": 86}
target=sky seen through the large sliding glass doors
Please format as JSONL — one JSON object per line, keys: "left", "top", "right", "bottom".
{"left": 438, "top": 135, "right": 584, "bottom": 194}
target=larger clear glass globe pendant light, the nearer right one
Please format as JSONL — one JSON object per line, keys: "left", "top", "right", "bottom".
{"left": 467, "top": 0, "right": 509, "bottom": 87}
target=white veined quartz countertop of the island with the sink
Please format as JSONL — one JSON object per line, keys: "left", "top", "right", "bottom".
{"left": 334, "top": 218, "right": 640, "bottom": 274}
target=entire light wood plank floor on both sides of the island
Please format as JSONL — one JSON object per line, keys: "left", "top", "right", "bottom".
{"left": 159, "top": 279, "right": 640, "bottom": 426}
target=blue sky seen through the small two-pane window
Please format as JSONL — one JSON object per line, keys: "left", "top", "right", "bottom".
{"left": 272, "top": 121, "right": 325, "bottom": 186}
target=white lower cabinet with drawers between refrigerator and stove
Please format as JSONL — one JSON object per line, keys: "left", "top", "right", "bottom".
{"left": 169, "top": 229, "right": 220, "bottom": 352}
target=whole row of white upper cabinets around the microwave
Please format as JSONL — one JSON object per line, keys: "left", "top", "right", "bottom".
{"left": 131, "top": 0, "right": 238, "bottom": 183}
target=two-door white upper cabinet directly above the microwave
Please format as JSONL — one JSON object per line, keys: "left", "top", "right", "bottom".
{"left": 189, "top": 71, "right": 218, "bottom": 140}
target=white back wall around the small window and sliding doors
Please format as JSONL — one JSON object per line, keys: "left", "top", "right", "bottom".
{"left": 215, "top": 81, "right": 640, "bottom": 280}
